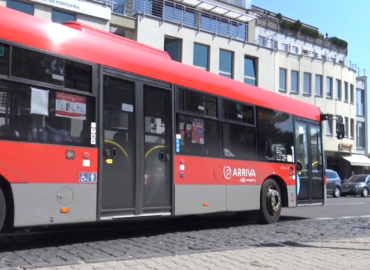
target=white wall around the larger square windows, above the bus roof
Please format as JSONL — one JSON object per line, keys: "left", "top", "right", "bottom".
{"left": 137, "top": 17, "right": 275, "bottom": 90}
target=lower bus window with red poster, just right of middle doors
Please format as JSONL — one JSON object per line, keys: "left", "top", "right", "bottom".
{"left": 176, "top": 114, "right": 220, "bottom": 157}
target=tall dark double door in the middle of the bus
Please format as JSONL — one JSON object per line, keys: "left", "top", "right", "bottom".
{"left": 98, "top": 70, "right": 173, "bottom": 219}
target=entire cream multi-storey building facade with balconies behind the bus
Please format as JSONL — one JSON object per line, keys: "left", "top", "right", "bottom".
{"left": 0, "top": 0, "right": 370, "bottom": 178}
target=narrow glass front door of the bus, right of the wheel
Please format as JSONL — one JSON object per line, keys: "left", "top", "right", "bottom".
{"left": 295, "top": 120, "right": 325, "bottom": 204}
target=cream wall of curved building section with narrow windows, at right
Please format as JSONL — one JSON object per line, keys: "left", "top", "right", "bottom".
{"left": 275, "top": 52, "right": 356, "bottom": 152}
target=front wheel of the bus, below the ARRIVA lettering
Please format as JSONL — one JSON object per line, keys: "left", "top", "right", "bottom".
{"left": 258, "top": 178, "right": 282, "bottom": 224}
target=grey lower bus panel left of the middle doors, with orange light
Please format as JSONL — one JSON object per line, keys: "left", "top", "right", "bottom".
{"left": 11, "top": 183, "right": 97, "bottom": 227}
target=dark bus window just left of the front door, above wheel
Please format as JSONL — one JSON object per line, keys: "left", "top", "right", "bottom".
{"left": 257, "top": 108, "right": 293, "bottom": 163}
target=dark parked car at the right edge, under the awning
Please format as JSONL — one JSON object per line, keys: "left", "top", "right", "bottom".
{"left": 342, "top": 174, "right": 370, "bottom": 197}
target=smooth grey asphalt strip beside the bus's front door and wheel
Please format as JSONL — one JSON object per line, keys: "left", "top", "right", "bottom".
{"left": 282, "top": 196, "right": 370, "bottom": 219}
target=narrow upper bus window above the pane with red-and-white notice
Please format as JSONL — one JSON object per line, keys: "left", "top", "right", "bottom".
{"left": 11, "top": 46, "right": 92, "bottom": 92}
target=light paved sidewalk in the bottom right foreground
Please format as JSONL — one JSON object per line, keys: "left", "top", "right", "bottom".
{"left": 38, "top": 237, "right": 370, "bottom": 270}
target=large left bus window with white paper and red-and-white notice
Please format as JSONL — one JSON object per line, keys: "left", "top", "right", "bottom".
{"left": 0, "top": 81, "right": 95, "bottom": 146}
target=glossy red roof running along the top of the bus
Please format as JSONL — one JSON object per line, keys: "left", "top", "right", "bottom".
{"left": 0, "top": 7, "right": 320, "bottom": 121}
